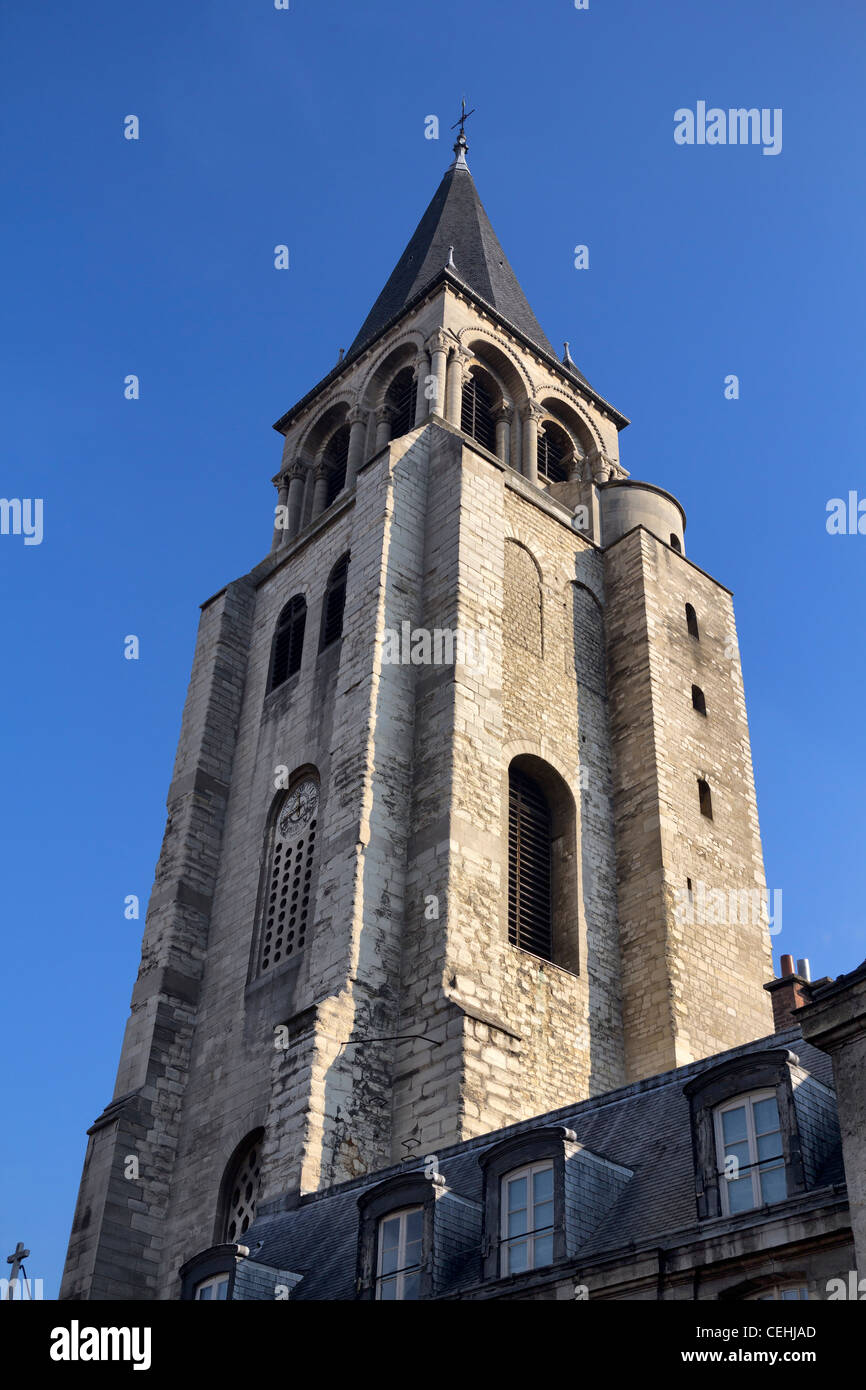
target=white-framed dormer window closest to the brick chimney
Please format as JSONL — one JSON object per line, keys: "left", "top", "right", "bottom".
{"left": 716, "top": 1090, "right": 788, "bottom": 1216}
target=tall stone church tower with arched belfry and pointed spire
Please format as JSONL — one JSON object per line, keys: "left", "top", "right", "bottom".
{"left": 61, "top": 135, "right": 773, "bottom": 1298}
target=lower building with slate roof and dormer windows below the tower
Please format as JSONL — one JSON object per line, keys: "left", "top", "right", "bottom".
{"left": 181, "top": 989, "right": 866, "bottom": 1302}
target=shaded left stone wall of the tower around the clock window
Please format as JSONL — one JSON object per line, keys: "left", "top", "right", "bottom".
{"left": 154, "top": 434, "right": 447, "bottom": 1287}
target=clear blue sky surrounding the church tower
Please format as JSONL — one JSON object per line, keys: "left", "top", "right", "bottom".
{"left": 0, "top": 0, "right": 866, "bottom": 1295}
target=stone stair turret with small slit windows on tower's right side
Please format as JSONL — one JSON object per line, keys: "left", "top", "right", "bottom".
{"left": 605, "top": 528, "right": 773, "bottom": 1080}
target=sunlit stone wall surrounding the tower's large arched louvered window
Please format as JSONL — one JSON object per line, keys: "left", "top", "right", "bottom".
{"left": 393, "top": 424, "right": 621, "bottom": 1156}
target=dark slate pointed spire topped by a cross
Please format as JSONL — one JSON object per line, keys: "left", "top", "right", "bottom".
{"left": 346, "top": 131, "right": 556, "bottom": 357}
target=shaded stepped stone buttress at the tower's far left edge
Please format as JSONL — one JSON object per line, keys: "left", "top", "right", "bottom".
{"left": 61, "top": 581, "right": 253, "bottom": 1298}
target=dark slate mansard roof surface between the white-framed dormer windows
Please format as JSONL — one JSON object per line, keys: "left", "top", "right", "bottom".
{"left": 245, "top": 1029, "right": 844, "bottom": 1301}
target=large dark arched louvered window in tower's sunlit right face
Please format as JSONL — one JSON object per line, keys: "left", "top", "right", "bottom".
{"left": 509, "top": 769, "right": 553, "bottom": 960}
